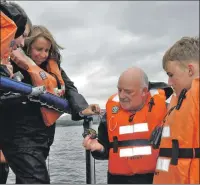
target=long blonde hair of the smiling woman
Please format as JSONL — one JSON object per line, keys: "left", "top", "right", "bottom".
{"left": 25, "top": 25, "right": 64, "bottom": 64}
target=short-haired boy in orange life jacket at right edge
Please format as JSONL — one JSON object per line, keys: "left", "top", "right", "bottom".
{"left": 154, "top": 37, "right": 200, "bottom": 184}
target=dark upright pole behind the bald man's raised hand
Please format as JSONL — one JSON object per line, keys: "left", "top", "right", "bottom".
{"left": 83, "top": 117, "right": 96, "bottom": 184}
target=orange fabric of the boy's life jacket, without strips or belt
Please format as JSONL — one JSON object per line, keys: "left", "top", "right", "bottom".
{"left": 154, "top": 78, "right": 200, "bottom": 184}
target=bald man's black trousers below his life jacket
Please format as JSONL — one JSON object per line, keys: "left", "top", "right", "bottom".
{"left": 107, "top": 172, "right": 154, "bottom": 184}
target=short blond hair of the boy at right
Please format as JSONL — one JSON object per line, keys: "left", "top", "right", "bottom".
{"left": 162, "top": 37, "right": 199, "bottom": 69}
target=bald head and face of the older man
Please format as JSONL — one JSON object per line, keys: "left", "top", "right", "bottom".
{"left": 118, "top": 67, "right": 149, "bottom": 111}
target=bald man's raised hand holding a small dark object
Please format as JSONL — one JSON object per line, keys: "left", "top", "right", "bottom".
{"left": 83, "top": 135, "right": 104, "bottom": 152}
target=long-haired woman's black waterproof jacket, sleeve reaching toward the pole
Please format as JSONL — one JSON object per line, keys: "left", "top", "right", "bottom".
{"left": 0, "top": 63, "right": 88, "bottom": 147}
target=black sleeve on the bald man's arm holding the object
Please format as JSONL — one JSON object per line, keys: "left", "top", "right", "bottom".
{"left": 91, "top": 113, "right": 109, "bottom": 160}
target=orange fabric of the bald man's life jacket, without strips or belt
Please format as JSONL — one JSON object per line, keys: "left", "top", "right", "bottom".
{"left": 106, "top": 91, "right": 167, "bottom": 176}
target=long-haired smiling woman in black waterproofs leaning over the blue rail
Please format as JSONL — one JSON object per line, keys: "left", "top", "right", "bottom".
{"left": 1, "top": 26, "right": 100, "bottom": 183}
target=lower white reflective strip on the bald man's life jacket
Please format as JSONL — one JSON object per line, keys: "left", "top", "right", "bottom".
{"left": 119, "top": 146, "right": 152, "bottom": 157}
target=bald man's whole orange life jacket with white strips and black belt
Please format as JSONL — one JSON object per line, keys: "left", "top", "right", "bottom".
{"left": 106, "top": 90, "right": 167, "bottom": 176}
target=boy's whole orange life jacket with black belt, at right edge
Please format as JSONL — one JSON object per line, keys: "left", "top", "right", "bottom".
{"left": 154, "top": 78, "right": 200, "bottom": 184}
